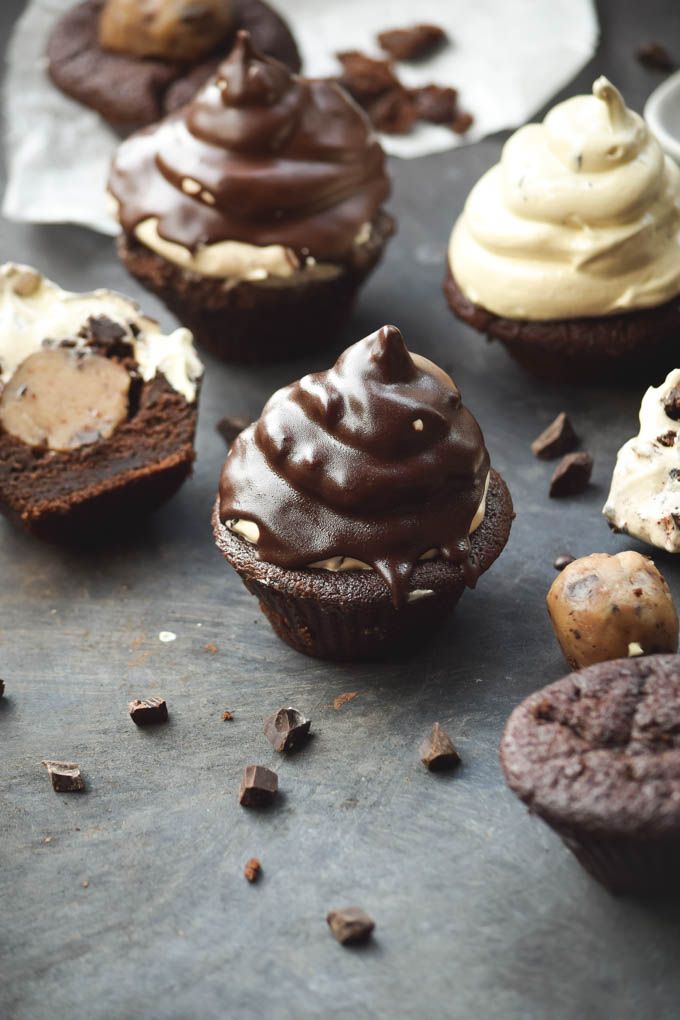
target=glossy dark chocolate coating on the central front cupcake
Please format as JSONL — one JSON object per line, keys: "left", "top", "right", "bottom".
{"left": 219, "top": 325, "right": 489, "bottom": 605}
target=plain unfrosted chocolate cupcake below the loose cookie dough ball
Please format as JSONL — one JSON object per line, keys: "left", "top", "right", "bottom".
{"left": 501, "top": 655, "right": 680, "bottom": 896}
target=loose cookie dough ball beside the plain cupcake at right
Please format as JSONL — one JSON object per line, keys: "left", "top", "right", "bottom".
{"left": 547, "top": 552, "right": 678, "bottom": 669}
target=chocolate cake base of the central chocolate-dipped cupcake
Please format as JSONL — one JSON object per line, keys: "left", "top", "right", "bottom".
{"left": 212, "top": 471, "right": 513, "bottom": 660}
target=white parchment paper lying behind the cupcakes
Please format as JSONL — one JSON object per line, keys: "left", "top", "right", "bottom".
{"left": 3, "top": 0, "right": 598, "bottom": 234}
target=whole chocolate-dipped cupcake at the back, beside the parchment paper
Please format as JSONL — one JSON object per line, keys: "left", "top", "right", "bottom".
{"left": 110, "top": 33, "right": 394, "bottom": 361}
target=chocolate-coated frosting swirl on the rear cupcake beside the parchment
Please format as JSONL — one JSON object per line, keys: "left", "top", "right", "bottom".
{"left": 109, "top": 32, "right": 389, "bottom": 262}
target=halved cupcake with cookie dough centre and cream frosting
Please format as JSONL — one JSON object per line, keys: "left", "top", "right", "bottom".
{"left": 0, "top": 263, "right": 203, "bottom": 541}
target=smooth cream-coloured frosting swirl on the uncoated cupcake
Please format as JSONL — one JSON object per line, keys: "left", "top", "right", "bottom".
{"left": 449, "top": 78, "right": 680, "bottom": 320}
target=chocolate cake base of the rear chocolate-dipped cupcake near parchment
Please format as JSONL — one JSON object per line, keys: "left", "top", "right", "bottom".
{"left": 118, "top": 211, "right": 395, "bottom": 362}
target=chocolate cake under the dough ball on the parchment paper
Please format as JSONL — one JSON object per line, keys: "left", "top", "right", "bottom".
{"left": 47, "top": 0, "right": 301, "bottom": 134}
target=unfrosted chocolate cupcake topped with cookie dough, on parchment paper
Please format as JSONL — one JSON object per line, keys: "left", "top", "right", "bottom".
{"left": 47, "top": 0, "right": 301, "bottom": 134}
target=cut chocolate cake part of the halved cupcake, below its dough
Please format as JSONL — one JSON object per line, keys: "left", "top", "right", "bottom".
{"left": 0, "top": 375, "right": 197, "bottom": 543}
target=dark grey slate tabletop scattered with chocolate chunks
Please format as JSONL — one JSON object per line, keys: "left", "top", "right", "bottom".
{"left": 0, "top": 0, "right": 680, "bottom": 1020}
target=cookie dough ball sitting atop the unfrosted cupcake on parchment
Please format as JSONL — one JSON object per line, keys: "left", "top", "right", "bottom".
{"left": 99, "top": 0, "right": 233, "bottom": 63}
